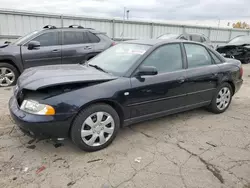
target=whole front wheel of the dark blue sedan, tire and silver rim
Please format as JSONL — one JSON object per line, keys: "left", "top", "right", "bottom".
{"left": 71, "top": 104, "right": 120, "bottom": 151}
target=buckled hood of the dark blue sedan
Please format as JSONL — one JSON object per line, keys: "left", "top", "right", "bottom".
{"left": 17, "top": 64, "right": 117, "bottom": 90}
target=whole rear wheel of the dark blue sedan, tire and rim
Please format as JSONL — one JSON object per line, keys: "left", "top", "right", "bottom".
{"left": 209, "top": 83, "right": 233, "bottom": 114}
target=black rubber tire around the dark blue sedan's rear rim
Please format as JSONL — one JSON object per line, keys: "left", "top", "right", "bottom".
{"left": 208, "top": 82, "right": 233, "bottom": 114}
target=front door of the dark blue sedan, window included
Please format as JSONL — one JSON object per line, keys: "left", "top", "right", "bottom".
{"left": 128, "top": 43, "right": 186, "bottom": 119}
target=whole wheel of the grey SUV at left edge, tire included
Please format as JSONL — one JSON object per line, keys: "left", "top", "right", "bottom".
{"left": 0, "top": 63, "right": 19, "bottom": 87}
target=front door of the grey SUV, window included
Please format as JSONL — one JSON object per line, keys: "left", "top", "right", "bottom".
{"left": 21, "top": 31, "right": 62, "bottom": 69}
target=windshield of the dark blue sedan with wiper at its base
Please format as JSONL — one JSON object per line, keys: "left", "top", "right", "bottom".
{"left": 88, "top": 43, "right": 150, "bottom": 76}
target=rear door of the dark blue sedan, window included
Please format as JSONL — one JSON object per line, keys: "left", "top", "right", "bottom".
{"left": 184, "top": 43, "right": 220, "bottom": 105}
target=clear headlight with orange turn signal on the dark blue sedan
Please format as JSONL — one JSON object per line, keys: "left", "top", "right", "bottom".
{"left": 20, "top": 100, "right": 55, "bottom": 116}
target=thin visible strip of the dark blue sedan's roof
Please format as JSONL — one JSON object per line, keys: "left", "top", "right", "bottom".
{"left": 124, "top": 39, "right": 203, "bottom": 46}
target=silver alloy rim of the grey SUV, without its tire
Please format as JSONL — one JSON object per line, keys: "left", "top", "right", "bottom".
{"left": 0, "top": 67, "right": 15, "bottom": 87}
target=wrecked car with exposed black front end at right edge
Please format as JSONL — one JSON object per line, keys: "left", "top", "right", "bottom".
{"left": 216, "top": 36, "right": 250, "bottom": 64}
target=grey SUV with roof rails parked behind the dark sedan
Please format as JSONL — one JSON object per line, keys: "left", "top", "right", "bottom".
{"left": 0, "top": 25, "right": 114, "bottom": 87}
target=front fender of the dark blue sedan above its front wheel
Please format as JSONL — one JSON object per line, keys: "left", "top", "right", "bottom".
{"left": 43, "top": 78, "right": 130, "bottom": 117}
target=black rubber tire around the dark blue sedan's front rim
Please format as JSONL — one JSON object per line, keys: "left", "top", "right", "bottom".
{"left": 70, "top": 103, "right": 120, "bottom": 152}
